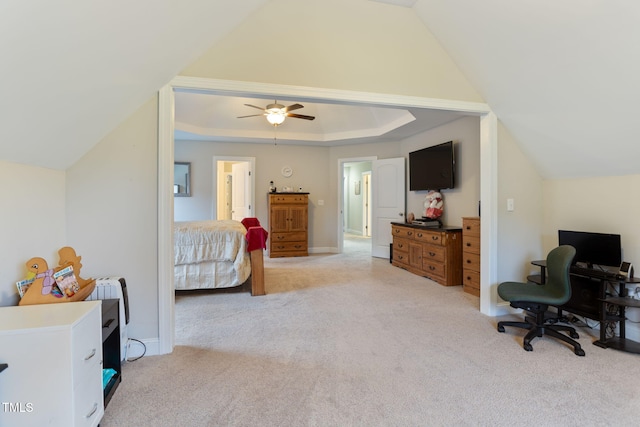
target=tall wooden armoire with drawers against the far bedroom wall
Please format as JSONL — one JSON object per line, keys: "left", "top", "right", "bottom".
{"left": 269, "top": 193, "right": 309, "bottom": 258}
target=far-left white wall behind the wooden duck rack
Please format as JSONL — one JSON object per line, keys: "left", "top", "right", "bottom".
{"left": 0, "top": 161, "right": 66, "bottom": 306}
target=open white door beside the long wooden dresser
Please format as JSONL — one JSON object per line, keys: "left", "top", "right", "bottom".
{"left": 371, "top": 157, "right": 406, "bottom": 259}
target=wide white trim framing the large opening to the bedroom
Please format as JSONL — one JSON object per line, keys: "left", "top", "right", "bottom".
{"left": 157, "top": 76, "right": 498, "bottom": 354}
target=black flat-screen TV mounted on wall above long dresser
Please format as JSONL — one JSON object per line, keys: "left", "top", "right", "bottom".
{"left": 409, "top": 141, "right": 455, "bottom": 191}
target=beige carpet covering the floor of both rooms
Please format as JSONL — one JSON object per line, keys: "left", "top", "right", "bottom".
{"left": 101, "top": 238, "right": 640, "bottom": 427}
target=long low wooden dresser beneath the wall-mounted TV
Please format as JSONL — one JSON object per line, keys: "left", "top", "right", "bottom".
{"left": 391, "top": 222, "right": 462, "bottom": 286}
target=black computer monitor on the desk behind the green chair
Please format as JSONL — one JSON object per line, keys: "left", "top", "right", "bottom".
{"left": 558, "top": 230, "right": 622, "bottom": 267}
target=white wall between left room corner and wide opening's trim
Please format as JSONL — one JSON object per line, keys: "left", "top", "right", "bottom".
{"left": 66, "top": 98, "right": 158, "bottom": 339}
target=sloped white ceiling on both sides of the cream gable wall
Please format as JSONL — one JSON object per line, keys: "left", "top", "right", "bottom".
{"left": 0, "top": 0, "right": 640, "bottom": 178}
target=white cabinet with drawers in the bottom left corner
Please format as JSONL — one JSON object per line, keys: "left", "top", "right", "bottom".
{"left": 0, "top": 301, "right": 104, "bottom": 427}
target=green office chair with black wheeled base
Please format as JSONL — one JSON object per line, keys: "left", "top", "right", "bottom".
{"left": 498, "top": 245, "right": 584, "bottom": 356}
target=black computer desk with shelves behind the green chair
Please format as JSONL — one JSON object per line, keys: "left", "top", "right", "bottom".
{"left": 527, "top": 260, "right": 640, "bottom": 354}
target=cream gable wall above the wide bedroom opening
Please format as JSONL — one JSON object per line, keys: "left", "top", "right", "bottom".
{"left": 180, "top": 0, "right": 484, "bottom": 102}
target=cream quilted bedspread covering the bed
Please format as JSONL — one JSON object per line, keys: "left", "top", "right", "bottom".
{"left": 173, "top": 220, "right": 251, "bottom": 290}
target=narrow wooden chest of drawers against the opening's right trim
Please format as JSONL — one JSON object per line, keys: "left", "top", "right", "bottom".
{"left": 462, "top": 217, "right": 480, "bottom": 297}
